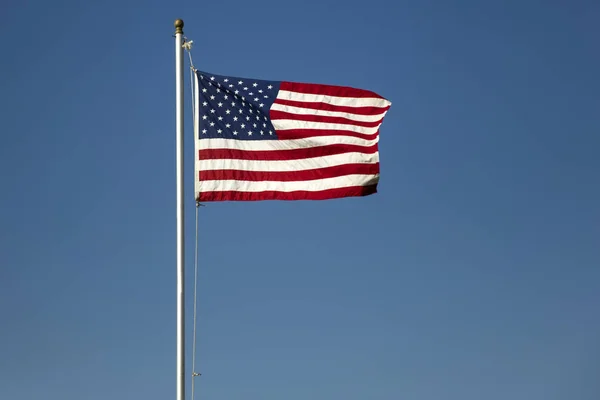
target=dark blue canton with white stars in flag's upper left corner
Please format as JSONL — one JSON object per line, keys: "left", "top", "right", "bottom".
{"left": 196, "top": 71, "right": 280, "bottom": 140}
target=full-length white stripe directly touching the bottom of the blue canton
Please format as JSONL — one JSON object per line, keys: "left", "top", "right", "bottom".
{"left": 196, "top": 136, "right": 379, "bottom": 151}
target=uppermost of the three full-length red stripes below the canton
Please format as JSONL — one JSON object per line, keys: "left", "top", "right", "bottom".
{"left": 198, "top": 143, "right": 377, "bottom": 161}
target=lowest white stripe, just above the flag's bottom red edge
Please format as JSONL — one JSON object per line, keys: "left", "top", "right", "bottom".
{"left": 198, "top": 174, "right": 379, "bottom": 192}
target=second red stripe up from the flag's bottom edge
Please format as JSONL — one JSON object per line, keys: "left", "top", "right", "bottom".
{"left": 198, "top": 163, "right": 379, "bottom": 182}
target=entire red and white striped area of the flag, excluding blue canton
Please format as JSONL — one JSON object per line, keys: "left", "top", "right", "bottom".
{"left": 196, "top": 82, "right": 391, "bottom": 201}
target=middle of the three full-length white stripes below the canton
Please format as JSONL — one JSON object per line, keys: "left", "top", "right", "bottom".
{"left": 196, "top": 153, "right": 379, "bottom": 172}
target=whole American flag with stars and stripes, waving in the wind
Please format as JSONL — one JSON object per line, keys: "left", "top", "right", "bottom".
{"left": 195, "top": 70, "right": 391, "bottom": 202}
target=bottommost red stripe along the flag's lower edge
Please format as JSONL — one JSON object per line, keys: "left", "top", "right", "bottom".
{"left": 197, "top": 185, "right": 377, "bottom": 201}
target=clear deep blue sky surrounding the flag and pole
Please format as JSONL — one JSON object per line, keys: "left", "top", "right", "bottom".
{"left": 0, "top": 0, "right": 600, "bottom": 400}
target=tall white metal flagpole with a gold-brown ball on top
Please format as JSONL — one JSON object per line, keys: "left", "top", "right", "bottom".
{"left": 175, "top": 19, "right": 185, "bottom": 400}
